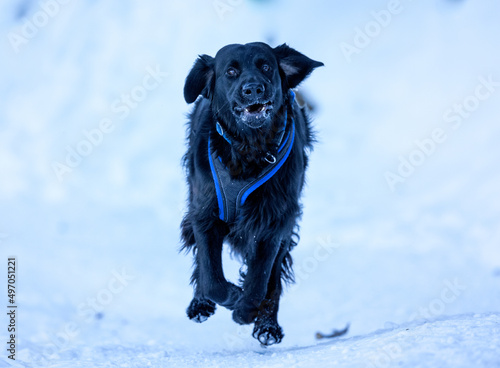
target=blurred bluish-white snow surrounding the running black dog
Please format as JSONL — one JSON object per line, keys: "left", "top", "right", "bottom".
{"left": 0, "top": 0, "right": 500, "bottom": 367}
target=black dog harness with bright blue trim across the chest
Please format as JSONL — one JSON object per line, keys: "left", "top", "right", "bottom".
{"left": 208, "top": 91, "right": 295, "bottom": 223}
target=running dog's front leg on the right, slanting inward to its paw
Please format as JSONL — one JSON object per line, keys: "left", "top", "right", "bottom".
{"left": 233, "top": 239, "right": 280, "bottom": 324}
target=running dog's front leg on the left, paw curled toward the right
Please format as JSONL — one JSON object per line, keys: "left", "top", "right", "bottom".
{"left": 193, "top": 224, "right": 241, "bottom": 309}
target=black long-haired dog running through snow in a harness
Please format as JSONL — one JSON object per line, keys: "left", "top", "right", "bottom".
{"left": 181, "top": 42, "right": 323, "bottom": 345}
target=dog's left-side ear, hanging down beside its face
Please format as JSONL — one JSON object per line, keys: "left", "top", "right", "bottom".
{"left": 184, "top": 55, "right": 215, "bottom": 103}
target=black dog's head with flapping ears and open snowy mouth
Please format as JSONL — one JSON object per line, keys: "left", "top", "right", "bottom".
{"left": 184, "top": 42, "right": 323, "bottom": 131}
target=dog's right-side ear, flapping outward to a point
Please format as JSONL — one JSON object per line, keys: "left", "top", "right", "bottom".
{"left": 273, "top": 43, "right": 324, "bottom": 88}
